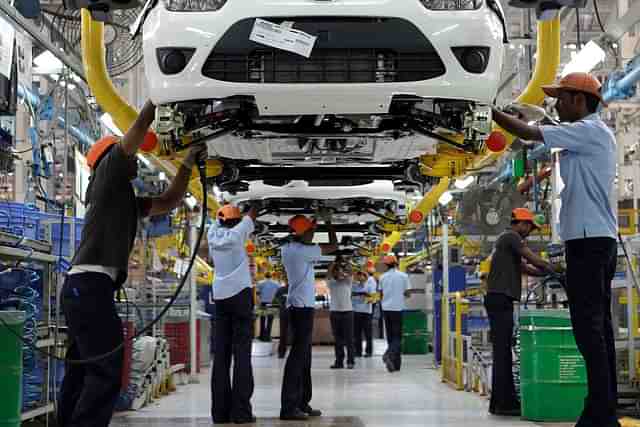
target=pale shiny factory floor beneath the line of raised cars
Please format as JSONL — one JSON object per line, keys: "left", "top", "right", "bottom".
{"left": 111, "top": 347, "right": 571, "bottom": 427}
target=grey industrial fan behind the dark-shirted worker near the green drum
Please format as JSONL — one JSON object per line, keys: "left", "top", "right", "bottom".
{"left": 456, "top": 183, "right": 526, "bottom": 235}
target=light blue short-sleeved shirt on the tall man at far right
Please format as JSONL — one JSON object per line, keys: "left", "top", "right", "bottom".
{"left": 540, "top": 114, "right": 618, "bottom": 242}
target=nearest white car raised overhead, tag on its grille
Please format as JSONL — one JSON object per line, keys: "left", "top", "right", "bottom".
{"left": 140, "top": 0, "right": 506, "bottom": 165}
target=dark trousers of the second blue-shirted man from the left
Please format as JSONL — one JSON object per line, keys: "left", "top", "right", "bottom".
{"left": 280, "top": 307, "right": 314, "bottom": 414}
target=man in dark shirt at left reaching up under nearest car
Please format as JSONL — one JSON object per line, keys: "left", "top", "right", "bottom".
{"left": 57, "top": 102, "right": 206, "bottom": 427}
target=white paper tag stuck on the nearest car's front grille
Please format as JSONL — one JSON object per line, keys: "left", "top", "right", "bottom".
{"left": 249, "top": 18, "right": 317, "bottom": 58}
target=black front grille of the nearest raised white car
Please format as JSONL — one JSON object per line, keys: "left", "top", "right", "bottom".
{"left": 202, "top": 18, "right": 445, "bottom": 83}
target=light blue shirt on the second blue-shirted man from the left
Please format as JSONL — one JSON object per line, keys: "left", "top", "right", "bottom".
{"left": 280, "top": 242, "right": 322, "bottom": 308}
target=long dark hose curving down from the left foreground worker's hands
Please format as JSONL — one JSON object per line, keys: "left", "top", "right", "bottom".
{"left": 0, "top": 161, "right": 208, "bottom": 365}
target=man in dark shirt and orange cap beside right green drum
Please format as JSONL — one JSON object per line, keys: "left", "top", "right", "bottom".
{"left": 484, "top": 208, "right": 552, "bottom": 416}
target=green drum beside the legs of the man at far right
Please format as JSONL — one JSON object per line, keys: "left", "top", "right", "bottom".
{"left": 520, "top": 310, "right": 587, "bottom": 422}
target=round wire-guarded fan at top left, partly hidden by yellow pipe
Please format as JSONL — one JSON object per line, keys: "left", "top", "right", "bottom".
{"left": 44, "top": 7, "right": 142, "bottom": 77}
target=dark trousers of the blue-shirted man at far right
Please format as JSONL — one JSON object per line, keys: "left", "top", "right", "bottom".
{"left": 566, "top": 237, "right": 618, "bottom": 427}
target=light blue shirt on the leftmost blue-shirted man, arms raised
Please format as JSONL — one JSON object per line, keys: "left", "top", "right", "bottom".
{"left": 207, "top": 216, "right": 254, "bottom": 300}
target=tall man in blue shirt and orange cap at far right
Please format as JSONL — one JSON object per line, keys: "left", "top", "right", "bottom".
{"left": 493, "top": 73, "right": 619, "bottom": 427}
